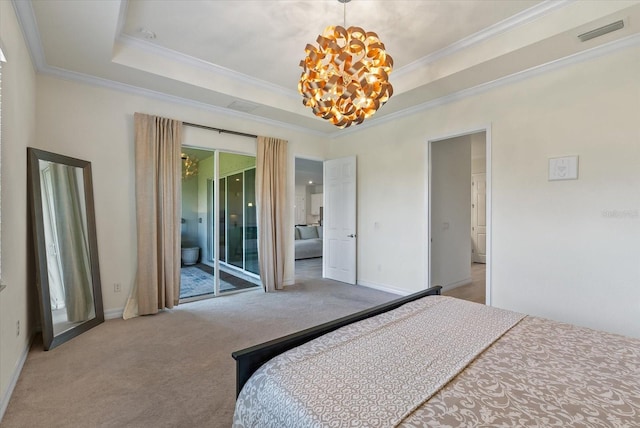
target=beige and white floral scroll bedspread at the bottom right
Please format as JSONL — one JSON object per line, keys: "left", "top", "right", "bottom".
{"left": 401, "top": 317, "right": 640, "bottom": 428}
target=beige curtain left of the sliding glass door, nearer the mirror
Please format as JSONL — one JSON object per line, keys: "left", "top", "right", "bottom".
{"left": 134, "top": 113, "right": 182, "bottom": 315}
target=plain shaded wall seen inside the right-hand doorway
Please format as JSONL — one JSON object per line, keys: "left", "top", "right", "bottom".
{"left": 430, "top": 135, "right": 471, "bottom": 290}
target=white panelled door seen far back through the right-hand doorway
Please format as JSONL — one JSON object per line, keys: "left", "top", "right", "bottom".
{"left": 471, "top": 173, "right": 487, "bottom": 263}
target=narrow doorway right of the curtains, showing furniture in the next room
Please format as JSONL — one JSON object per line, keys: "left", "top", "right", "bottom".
{"left": 294, "top": 158, "right": 324, "bottom": 283}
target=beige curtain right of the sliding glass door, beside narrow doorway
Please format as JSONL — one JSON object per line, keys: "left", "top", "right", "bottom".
{"left": 256, "top": 137, "right": 287, "bottom": 292}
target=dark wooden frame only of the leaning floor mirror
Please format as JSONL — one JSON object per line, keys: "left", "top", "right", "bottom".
{"left": 27, "top": 147, "right": 104, "bottom": 351}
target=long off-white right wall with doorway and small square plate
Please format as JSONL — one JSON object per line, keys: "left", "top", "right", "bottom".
{"left": 329, "top": 45, "right": 640, "bottom": 337}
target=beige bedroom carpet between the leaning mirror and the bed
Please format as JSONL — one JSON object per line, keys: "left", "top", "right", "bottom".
{"left": 1, "top": 280, "right": 398, "bottom": 428}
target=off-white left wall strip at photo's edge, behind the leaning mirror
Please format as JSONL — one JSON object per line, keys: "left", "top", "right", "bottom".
{"left": 0, "top": 1, "right": 40, "bottom": 418}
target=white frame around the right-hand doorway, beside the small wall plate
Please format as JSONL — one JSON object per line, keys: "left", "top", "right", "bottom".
{"left": 425, "top": 123, "right": 493, "bottom": 306}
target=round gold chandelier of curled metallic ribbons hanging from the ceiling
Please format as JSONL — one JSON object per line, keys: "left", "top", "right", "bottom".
{"left": 298, "top": 0, "right": 393, "bottom": 128}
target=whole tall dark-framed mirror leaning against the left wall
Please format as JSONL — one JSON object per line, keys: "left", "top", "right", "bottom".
{"left": 27, "top": 147, "right": 104, "bottom": 350}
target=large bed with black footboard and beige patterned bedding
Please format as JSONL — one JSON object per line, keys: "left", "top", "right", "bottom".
{"left": 233, "top": 288, "right": 640, "bottom": 427}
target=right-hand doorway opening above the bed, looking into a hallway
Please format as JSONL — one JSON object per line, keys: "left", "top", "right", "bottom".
{"left": 429, "top": 128, "right": 491, "bottom": 304}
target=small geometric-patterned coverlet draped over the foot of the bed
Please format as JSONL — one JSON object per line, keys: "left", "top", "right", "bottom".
{"left": 234, "top": 296, "right": 523, "bottom": 428}
